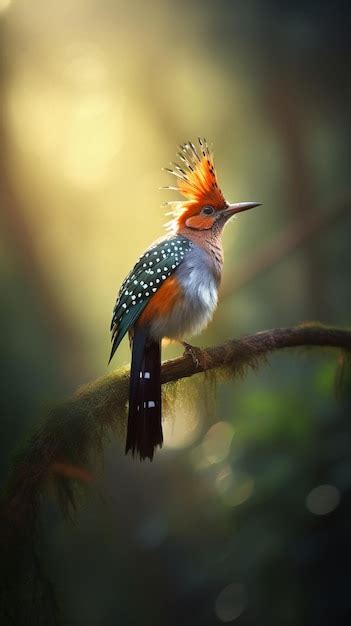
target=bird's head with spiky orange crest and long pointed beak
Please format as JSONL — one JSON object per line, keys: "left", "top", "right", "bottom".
{"left": 164, "top": 139, "right": 259, "bottom": 231}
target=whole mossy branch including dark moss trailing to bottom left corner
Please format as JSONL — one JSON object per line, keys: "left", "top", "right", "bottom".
{"left": 0, "top": 324, "right": 351, "bottom": 626}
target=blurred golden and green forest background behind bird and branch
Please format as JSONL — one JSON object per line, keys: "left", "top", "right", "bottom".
{"left": 0, "top": 0, "right": 351, "bottom": 626}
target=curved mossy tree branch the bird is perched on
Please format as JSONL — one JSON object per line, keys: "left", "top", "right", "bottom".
{"left": 0, "top": 323, "right": 351, "bottom": 537}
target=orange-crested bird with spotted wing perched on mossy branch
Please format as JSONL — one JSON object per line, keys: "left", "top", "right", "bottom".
{"left": 109, "top": 138, "right": 260, "bottom": 461}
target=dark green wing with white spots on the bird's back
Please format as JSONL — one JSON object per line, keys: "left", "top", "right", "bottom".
{"left": 110, "top": 235, "right": 192, "bottom": 361}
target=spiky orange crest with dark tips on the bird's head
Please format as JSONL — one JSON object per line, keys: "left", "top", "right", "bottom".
{"left": 164, "top": 138, "right": 227, "bottom": 228}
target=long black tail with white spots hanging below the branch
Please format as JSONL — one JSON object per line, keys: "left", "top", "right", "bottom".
{"left": 126, "top": 327, "right": 163, "bottom": 461}
